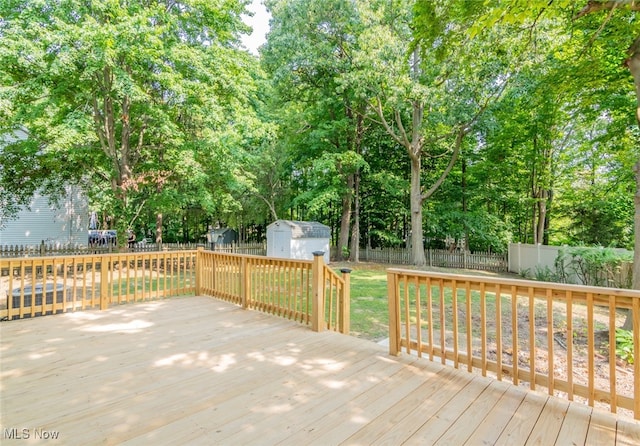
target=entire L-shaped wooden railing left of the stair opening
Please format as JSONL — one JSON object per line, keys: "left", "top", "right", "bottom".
{"left": 0, "top": 248, "right": 350, "bottom": 333}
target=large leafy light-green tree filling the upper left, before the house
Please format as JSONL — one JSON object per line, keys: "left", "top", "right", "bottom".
{"left": 0, "top": 0, "right": 252, "bottom": 241}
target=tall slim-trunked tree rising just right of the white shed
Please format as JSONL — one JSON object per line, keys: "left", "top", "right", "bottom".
{"left": 261, "top": 0, "right": 364, "bottom": 260}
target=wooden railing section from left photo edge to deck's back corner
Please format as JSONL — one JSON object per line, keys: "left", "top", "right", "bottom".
{"left": 0, "top": 250, "right": 196, "bottom": 320}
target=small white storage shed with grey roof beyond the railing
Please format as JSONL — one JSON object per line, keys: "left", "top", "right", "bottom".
{"left": 267, "top": 220, "right": 331, "bottom": 263}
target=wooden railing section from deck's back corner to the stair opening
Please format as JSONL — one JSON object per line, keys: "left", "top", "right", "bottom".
{"left": 196, "top": 250, "right": 350, "bottom": 333}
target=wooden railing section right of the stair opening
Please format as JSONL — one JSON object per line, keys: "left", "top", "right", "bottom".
{"left": 387, "top": 269, "right": 640, "bottom": 419}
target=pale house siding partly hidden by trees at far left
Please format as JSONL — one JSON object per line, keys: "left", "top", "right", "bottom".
{"left": 0, "top": 187, "right": 89, "bottom": 246}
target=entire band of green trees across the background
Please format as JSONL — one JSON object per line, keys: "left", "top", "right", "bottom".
{"left": 0, "top": 0, "right": 640, "bottom": 258}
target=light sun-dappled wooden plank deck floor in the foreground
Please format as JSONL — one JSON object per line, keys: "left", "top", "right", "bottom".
{"left": 0, "top": 297, "right": 640, "bottom": 445}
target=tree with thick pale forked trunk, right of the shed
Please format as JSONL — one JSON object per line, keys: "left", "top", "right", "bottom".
{"left": 344, "top": 1, "right": 507, "bottom": 265}
